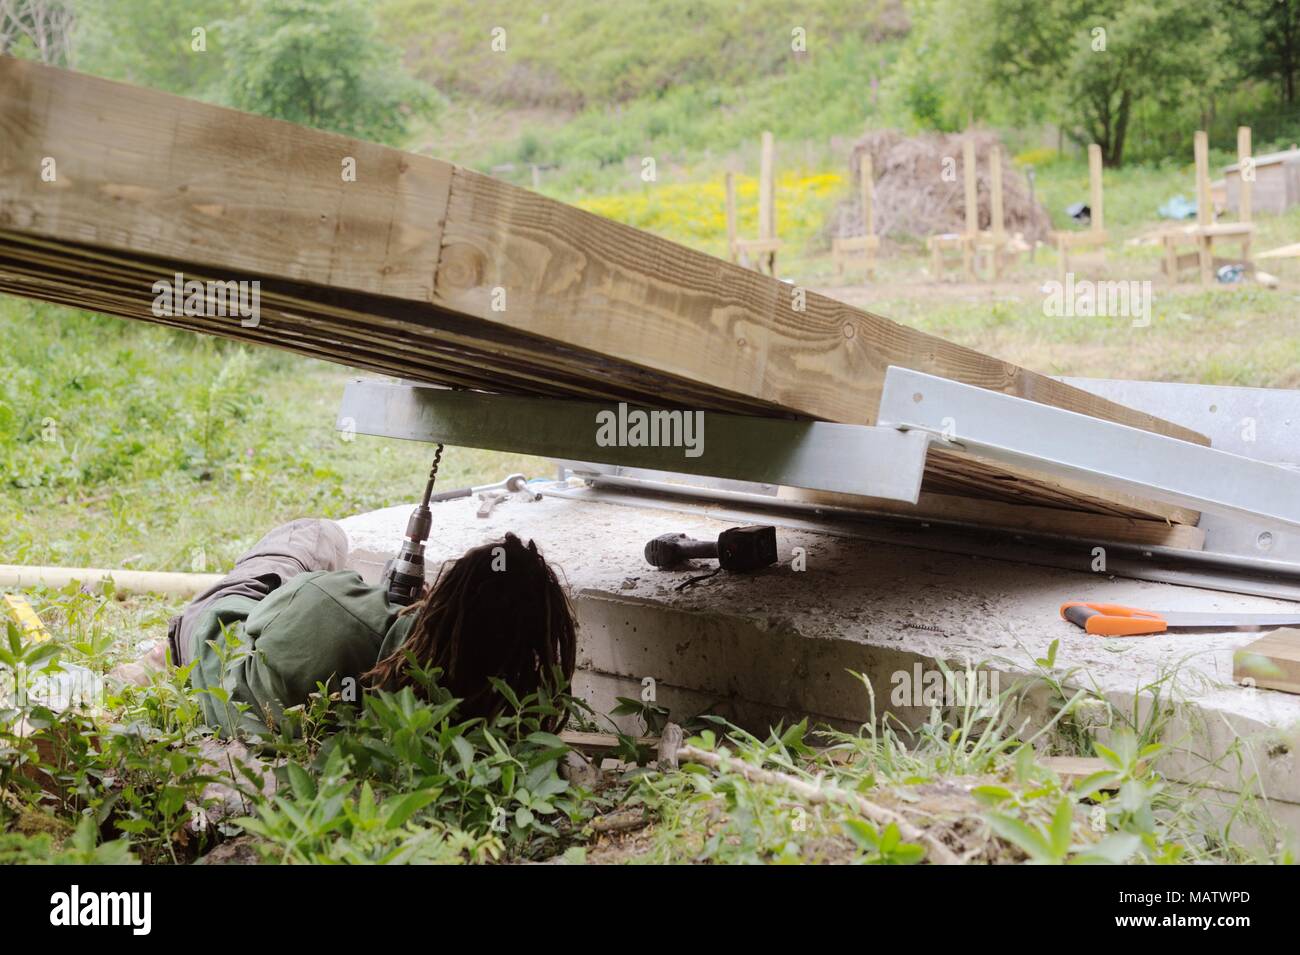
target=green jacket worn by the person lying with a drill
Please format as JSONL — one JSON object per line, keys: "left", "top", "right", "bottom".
{"left": 187, "top": 570, "right": 415, "bottom": 735}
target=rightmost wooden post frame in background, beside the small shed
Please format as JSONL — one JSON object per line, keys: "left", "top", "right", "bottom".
{"left": 1161, "top": 126, "right": 1255, "bottom": 286}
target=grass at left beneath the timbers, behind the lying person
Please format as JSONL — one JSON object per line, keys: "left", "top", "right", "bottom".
{"left": 0, "top": 299, "right": 551, "bottom": 572}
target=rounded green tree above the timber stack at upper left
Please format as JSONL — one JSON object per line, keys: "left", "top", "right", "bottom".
{"left": 221, "top": 0, "right": 436, "bottom": 144}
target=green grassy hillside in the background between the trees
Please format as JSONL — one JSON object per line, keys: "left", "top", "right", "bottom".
{"left": 377, "top": 0, "right": 907, "bottom": 192}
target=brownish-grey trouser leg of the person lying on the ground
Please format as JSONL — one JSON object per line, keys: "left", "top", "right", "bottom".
{"left": 166, "top": 517, "right": 347, "bottom": 667}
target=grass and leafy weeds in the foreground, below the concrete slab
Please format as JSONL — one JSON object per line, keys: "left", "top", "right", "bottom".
{"left": 0, "top": 600, "right": 1290, "bottom": 864}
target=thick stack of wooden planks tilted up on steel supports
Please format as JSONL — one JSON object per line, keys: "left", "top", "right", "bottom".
{"left": 0, "top": 57, "right": 1208, "bottom": 537}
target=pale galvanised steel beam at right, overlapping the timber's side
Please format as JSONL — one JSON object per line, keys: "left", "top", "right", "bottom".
{"left": 878, "top": 366, "right": 1300, "bottom": 529}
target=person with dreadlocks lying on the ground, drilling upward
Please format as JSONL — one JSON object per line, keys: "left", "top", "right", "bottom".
{"left": 120, "top": 520, "right": 576, "bottom": 735}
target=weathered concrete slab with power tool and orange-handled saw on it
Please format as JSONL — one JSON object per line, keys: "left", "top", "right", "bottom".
{"left": 342, "top": 488, "right": 1300, "bottom": 833}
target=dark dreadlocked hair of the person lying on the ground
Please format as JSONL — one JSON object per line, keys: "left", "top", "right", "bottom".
{"left": 363, "top": 534, "right": 576, "bottom": 730}
